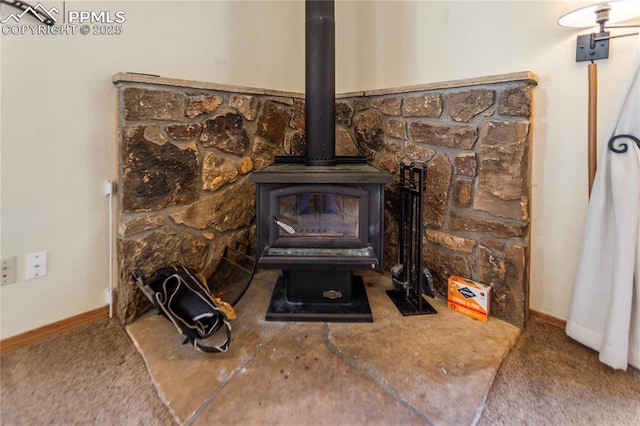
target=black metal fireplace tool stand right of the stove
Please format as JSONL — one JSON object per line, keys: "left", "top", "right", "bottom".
{"left": 387, "top": 163, "right": 437, "bottom": 316}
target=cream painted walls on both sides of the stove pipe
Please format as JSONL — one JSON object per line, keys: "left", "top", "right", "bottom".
{"left": 0, "top": 1, "right": 637, "bottom": 338}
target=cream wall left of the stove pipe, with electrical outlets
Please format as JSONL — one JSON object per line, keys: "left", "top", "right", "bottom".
{"left": 0, "top": 1, "right": 304, "bottom": 338}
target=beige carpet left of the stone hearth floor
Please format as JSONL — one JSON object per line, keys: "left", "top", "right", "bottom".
{"left": 0, "top": 319, "right": 175, "bottom": 426}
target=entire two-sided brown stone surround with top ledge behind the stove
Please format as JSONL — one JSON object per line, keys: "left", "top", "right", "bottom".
{"left": 113, "top": 72, "right": 537, "bottom": 327}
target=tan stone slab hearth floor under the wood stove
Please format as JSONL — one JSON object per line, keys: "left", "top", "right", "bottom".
{"left": 127, "top": 271, "right": 520, "bottom": 425}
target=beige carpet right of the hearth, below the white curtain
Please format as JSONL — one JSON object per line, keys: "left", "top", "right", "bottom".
{"left": 478, "top": 312, "right": 640, "bottom": 426}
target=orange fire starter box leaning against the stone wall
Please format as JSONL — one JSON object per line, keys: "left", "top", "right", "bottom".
{"left": 447, "top": 275, "right": 491, "bottom": 322}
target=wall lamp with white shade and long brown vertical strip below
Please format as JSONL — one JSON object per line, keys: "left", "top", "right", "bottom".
{"left": 558, "top": 0, "right": 640, "bottom": 195}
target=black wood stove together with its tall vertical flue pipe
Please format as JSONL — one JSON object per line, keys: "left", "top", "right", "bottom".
{"left": 251, "top": 1, "right": 392, "bottom": 322}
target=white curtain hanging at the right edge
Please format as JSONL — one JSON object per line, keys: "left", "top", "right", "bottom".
{"left": 566, "top": 40, "right": 640, "bottom": 370}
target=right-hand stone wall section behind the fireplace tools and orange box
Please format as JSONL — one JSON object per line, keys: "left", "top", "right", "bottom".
{"left": 360, "top": 82, "right": 532, "bottom": 327}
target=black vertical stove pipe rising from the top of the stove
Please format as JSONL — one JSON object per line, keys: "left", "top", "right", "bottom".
{"left": 305, "top": 0, "right": 336, "bottom": 166}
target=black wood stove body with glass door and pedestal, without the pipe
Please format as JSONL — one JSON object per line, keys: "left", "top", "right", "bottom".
{"left": 251, "top": 159, "right": 391, "bottom": 321}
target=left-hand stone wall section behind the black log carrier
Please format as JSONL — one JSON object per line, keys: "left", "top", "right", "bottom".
{"left": 118, "top": 83, "right": 304, "bottom": 323}
